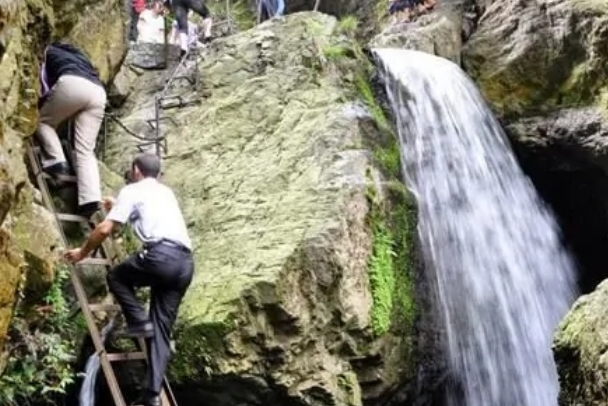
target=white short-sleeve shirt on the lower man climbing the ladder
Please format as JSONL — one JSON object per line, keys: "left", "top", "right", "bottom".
{"left": 106, "top": 178, "right": 192, "bottom": 249}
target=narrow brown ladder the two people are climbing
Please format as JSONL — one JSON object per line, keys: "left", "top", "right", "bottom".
{"left": 26, "top": 137, "right": 177, "bottom": 406}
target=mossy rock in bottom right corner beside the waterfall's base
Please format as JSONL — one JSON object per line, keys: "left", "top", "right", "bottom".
{"left": 553, "top": 281, "right": 608, "bottom": 406}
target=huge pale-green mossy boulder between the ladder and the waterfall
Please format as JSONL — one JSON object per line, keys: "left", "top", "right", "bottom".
{"left": 106, "top": 13, "right": 415, "bottom": 406}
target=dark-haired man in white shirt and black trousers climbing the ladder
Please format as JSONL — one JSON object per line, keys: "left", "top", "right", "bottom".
{"left": 65, "top": 154, "right": 194, "bottom": 406}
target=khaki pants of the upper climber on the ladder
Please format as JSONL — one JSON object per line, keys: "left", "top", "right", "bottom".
{"left": 38, "top": 75, "right": 106, "bottom": 205}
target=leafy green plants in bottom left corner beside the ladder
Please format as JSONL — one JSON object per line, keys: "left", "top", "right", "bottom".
{"left": 0, "top": 267, "right": 76, "bottom": 406}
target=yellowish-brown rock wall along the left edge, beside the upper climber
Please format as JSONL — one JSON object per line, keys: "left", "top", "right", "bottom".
{"left": 0, "top": 0, "right": 125, "bottom": 373}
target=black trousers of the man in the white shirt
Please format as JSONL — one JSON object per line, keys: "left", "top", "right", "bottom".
{"left": 108, "top": 243, "right": 194, "bottom": 394}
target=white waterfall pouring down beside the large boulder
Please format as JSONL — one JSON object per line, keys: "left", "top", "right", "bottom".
{"left": 374, "top": 49, "right": 575, "bottom": 406}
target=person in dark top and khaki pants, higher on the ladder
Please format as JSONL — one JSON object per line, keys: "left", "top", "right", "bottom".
{"left": 36, "top": 43, "right": 106, "bottom": 217}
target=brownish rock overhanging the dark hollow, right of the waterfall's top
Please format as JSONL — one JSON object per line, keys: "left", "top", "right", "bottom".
{"left": 463, "top": 0, "right": 608, "bottom": 116}
